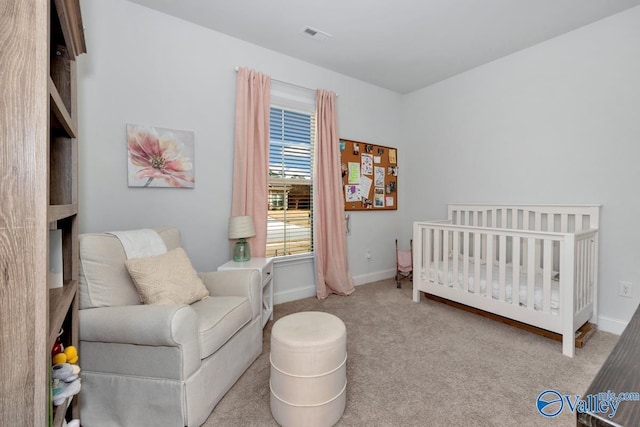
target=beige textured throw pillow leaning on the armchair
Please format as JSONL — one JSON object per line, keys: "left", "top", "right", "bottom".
{"left": 125, "top": 248, "right": 209, "bottom": 305}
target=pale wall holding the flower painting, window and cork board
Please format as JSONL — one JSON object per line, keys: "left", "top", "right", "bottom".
{"left": 78, "top": 0, "right": 403, "bottom": 302}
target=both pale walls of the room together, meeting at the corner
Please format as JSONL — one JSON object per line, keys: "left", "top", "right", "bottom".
{"left": 78, "top": 0, "right": 640, "bottom": 330}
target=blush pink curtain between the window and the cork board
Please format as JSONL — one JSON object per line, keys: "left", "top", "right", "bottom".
{"left": 313, "top": 89, "right": 355, "bottom": 299}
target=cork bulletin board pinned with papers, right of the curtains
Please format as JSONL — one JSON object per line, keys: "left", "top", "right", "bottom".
{"left": 340, "top": 139, "right": 398, "bottom": 211}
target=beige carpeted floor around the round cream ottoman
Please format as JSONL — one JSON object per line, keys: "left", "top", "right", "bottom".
{"left": 204, "top": 280, "right": 618, "bottom": 427}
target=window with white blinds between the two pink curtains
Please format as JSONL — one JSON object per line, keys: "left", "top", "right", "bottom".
{"left": 266, "top": 105, "right": 315, "bottom": 257}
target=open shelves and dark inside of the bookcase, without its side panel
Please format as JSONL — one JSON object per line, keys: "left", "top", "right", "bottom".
{"left": 47, "top": 0, "right": 86, "bottom": 427}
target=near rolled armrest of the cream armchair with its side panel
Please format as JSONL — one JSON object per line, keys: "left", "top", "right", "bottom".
{"left": 78, "top": 305, "right": 200, "bottom": 378}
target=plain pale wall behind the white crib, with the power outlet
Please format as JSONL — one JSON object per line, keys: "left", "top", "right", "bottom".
{"left": 401, "top": 7, "right": 640, "bottom": 332}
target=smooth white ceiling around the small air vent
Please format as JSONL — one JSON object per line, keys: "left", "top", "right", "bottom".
{"left": 131, "top": 0, "right": 640, "bottom": 93}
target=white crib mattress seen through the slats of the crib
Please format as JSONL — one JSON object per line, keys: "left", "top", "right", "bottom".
{"left": 431, "top": 259, "right": 560, "bottom": 314}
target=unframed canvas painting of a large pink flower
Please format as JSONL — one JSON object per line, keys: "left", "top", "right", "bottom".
{"left": 127, "top": 125, "right": 195, "bottom": 188}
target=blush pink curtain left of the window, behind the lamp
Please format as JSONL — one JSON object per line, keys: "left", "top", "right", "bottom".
{"left": 231, "top": 68, "right": 271, "bottom": 257}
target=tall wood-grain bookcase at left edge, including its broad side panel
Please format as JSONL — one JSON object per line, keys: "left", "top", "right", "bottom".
{"left": 0, "top": 0, "right": 86, "bottom": 427}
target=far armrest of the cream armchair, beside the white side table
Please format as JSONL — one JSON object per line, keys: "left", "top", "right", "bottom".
{"left": 198, "top": 269, "right": 262, "bottom": 319}
